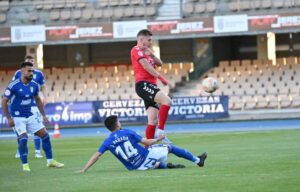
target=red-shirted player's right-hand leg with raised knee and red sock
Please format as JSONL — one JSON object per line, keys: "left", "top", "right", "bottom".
{"left": 154, "top": 91, "right": 171, "bottom": 134}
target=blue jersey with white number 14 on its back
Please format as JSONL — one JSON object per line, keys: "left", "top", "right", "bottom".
{"left": 98, "top": 129, "right": 149, "bottom": 170}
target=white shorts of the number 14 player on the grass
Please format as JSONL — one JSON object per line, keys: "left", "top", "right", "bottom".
{"left": 137, "top": 144, "right": 169, "bottom": 170}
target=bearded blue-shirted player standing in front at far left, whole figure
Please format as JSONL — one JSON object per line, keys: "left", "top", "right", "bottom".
{"left": 1, "top": 62, "right": 64, "bottom": 171}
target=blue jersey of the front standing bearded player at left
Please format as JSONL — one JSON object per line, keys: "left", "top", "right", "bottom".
{"left": 4, "top": 78, "right": 40, "bottom": 118}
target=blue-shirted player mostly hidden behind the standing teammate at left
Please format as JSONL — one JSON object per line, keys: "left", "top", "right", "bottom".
{"left": 12, "top": 55, "right": 47, "bottom": 158}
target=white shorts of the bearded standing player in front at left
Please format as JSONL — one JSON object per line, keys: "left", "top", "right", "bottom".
{"left": 13, "top": 115, "right": 45, "bottom": 135}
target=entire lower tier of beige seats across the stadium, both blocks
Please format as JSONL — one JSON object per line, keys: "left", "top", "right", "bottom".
{"left": 0, "top": 57, "right": 300, "bottom": 110}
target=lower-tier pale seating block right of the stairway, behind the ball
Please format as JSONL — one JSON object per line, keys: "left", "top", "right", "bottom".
{"left": 173, "top": 57, "right": 300, "bottom": 110}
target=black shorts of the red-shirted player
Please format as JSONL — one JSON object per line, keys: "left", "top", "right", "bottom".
{"left": 135, "top": 81, "right": 160, "bottom": 109}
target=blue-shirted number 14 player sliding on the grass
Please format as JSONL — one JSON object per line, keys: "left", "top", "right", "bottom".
{"left": 79, "top": 116, "right": 207, "bottom": 172}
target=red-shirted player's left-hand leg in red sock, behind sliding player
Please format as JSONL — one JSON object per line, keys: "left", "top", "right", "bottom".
{"left": 145, "top": 106, "right": 158, "bottom": 139}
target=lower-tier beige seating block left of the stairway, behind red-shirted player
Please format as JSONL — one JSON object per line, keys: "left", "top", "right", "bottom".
{"left": 0, "top": 63, "right": 193, "bottom": 102}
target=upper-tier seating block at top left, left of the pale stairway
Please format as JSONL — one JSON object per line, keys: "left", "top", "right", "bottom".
{"left": 0, "top": 0, "right": 163, "bottom": 25}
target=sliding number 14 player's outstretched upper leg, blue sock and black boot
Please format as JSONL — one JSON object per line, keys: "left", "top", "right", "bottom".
{"left": 168, "top": 144, "right": 207, "bottom": 167}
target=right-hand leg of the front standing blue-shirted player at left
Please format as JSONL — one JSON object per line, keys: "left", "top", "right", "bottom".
{"left": 28, "top": 116, "right": 64, "bottom": 168}
